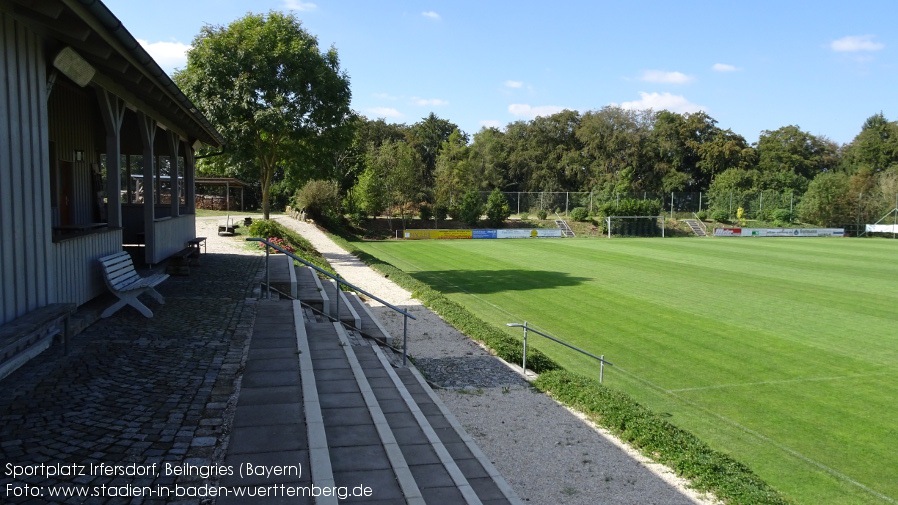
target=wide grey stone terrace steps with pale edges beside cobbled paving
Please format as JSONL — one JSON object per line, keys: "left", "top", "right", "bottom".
{"left": 218, "top": 278, "right": 520, "bottom": 504}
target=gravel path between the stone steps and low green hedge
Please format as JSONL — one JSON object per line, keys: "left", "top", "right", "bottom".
{"left": 278, "top": 217, "right": 715, "bottom": 505}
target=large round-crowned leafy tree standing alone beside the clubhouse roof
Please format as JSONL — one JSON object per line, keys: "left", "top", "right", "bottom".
{"left": 175, "top": 11, "right": 350, "bottom": 219}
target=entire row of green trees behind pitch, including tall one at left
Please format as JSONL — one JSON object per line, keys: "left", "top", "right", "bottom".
{"left": 175, "top": 12, "right": 898, "bottom": 225}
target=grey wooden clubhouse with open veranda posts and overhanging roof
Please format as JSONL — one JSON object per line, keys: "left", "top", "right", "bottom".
{"left": 0, "top": 0, "right": 223, "bottom": 325}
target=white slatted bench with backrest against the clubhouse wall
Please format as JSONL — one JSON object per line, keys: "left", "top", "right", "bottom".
{"left": 99, "top": 251, "right": 168, "bottom": 317}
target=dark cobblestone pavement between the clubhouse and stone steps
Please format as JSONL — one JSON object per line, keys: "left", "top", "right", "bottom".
{"left": 0, "top": 243, "right": 263, "bottom": 504}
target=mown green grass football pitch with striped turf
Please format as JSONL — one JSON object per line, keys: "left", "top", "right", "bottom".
{"left": 355, "top": 238, "right": 898, "bottom": 504}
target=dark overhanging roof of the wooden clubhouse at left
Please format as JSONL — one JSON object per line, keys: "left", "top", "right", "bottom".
{"left": 0, "top": 0, "right": 224, "bottom": 146}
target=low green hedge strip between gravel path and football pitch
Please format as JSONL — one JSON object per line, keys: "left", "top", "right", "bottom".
{"left": 332, "top": 229, "right": 788, "bottom": 505}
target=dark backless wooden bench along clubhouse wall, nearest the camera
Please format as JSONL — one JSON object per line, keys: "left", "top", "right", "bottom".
{"left": 0, "top": 303, "right": 76, "bottom": 379}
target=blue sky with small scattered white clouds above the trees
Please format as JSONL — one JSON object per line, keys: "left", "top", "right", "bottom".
{"left": 104, "top": 0, "right": 898, "bottom": 144}
